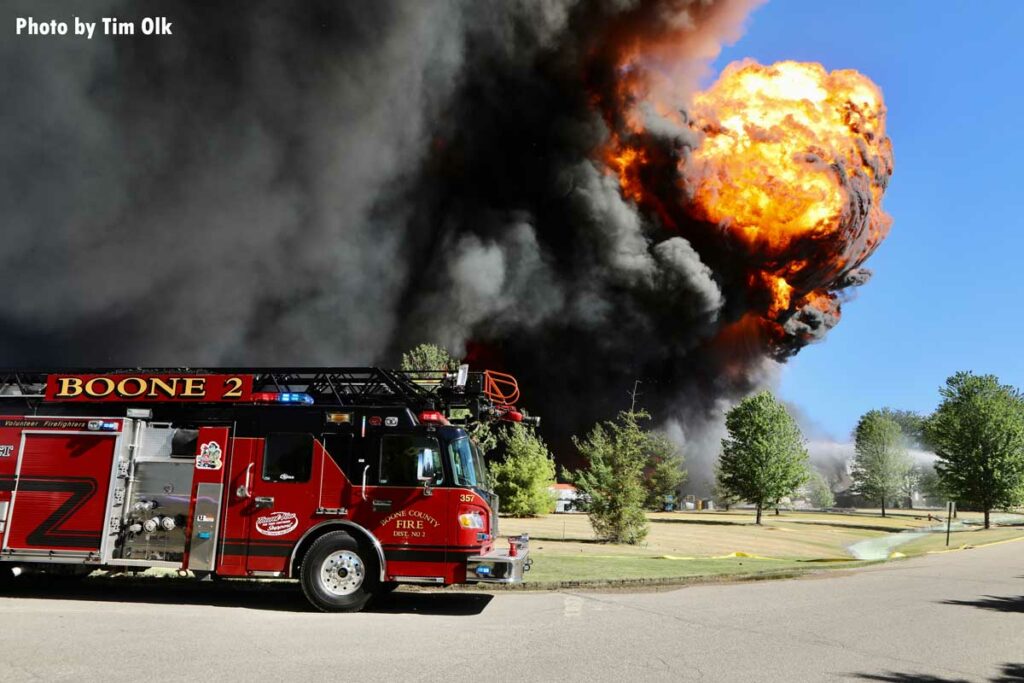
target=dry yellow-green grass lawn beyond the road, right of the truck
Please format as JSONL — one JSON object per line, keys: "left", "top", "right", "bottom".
{"left": 500, "top": 510, "right": 1024, "bottom": 583}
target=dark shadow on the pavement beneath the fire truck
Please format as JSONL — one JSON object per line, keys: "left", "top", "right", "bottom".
{"left": 0, "top": 577, "right": 493, "bottom": 615}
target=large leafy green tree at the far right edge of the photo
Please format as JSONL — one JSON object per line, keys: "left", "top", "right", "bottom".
{"left": 925, "top": 372, "right": 1024, "bottom": 528}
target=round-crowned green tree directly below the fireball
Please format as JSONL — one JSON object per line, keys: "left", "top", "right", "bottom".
{"left": 717, "top": 391, "right": 808, "bottom": 524}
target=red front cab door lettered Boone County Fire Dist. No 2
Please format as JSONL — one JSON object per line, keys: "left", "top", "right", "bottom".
{"left": 352, "top": 430, "right": 452, "bottom": 577}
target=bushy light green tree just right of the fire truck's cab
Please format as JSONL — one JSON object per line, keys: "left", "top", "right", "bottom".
{"left": 489, "top": 424, "right": 555, "bottom": 517}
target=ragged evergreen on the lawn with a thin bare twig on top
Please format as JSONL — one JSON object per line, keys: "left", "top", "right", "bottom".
{"left": 563, "top": 411, "right": 650, "bottom": 544}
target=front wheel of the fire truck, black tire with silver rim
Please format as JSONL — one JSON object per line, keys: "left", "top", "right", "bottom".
{"left": 299, "top": 531, "right": 380, "bottom": 612}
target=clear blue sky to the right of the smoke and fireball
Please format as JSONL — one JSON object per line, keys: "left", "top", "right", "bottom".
{"left": 714, "top": 0, "right": 1024, "bottom": 440}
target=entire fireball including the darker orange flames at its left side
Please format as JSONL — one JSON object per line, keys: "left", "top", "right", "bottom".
{"left": 604, "top": 57, "right": 893, "bottom": 348}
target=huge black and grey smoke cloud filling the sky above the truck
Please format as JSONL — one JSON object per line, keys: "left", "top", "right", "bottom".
{"left": 0, "top": 0, "right": 884, "bottom": 478}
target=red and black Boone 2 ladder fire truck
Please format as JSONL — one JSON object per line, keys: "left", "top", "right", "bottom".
{"left": 0, "top": 366, "right": 538, "bottom": 611}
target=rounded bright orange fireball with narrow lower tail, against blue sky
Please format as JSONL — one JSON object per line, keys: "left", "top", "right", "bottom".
{"left": 680, "top": 61, "right": 893, "bottom": 331}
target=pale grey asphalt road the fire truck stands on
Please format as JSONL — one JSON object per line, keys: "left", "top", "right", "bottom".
{"left": 0, "top": 543, "right": 1024, "bottom": 681}
